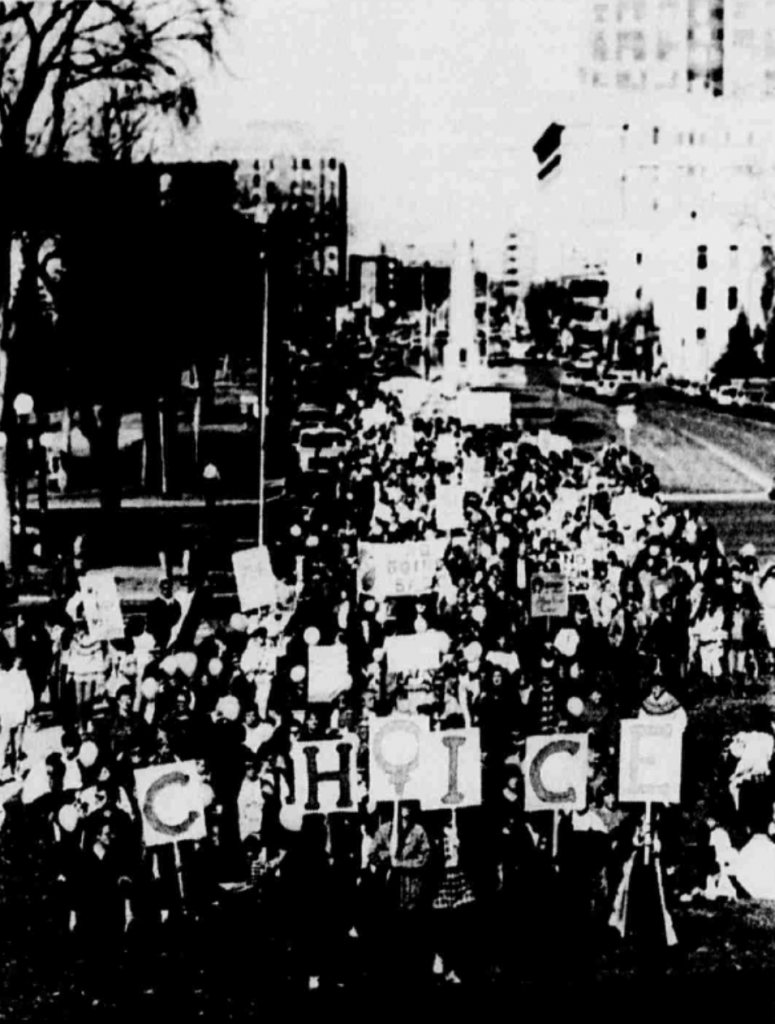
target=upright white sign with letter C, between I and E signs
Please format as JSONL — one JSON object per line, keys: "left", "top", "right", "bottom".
{"left": 524, "top": 733, "right": 589, "bottom": 811}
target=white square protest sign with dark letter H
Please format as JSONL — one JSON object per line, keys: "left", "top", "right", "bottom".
{"left": 291, "top": 733, "right": 358, "bottom": 814}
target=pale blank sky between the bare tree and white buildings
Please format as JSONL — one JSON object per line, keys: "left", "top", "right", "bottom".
{"left": 180, "top": 0, "right": 584, "bottom": 264}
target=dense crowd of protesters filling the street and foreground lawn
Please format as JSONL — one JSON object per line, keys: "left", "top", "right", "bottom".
{"left": 0, "top": 380, "right": 775, "bottom": 992}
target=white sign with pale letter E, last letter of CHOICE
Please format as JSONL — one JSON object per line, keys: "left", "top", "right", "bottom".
{"left": 619, "top": 719, "right": 682, "bottom": 804}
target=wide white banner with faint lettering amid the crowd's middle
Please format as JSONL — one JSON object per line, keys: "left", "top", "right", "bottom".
{"left": 358, "top": 540, "right": 447, "bottom": 598}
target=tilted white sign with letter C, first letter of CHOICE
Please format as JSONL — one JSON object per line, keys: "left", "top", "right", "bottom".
{"left": 134, "top": 761, "right": 207, "bottom": 846}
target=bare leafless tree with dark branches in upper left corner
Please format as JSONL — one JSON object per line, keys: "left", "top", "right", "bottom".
{"left": 0, "top": 0, "right": 234, "bottom": 565}
